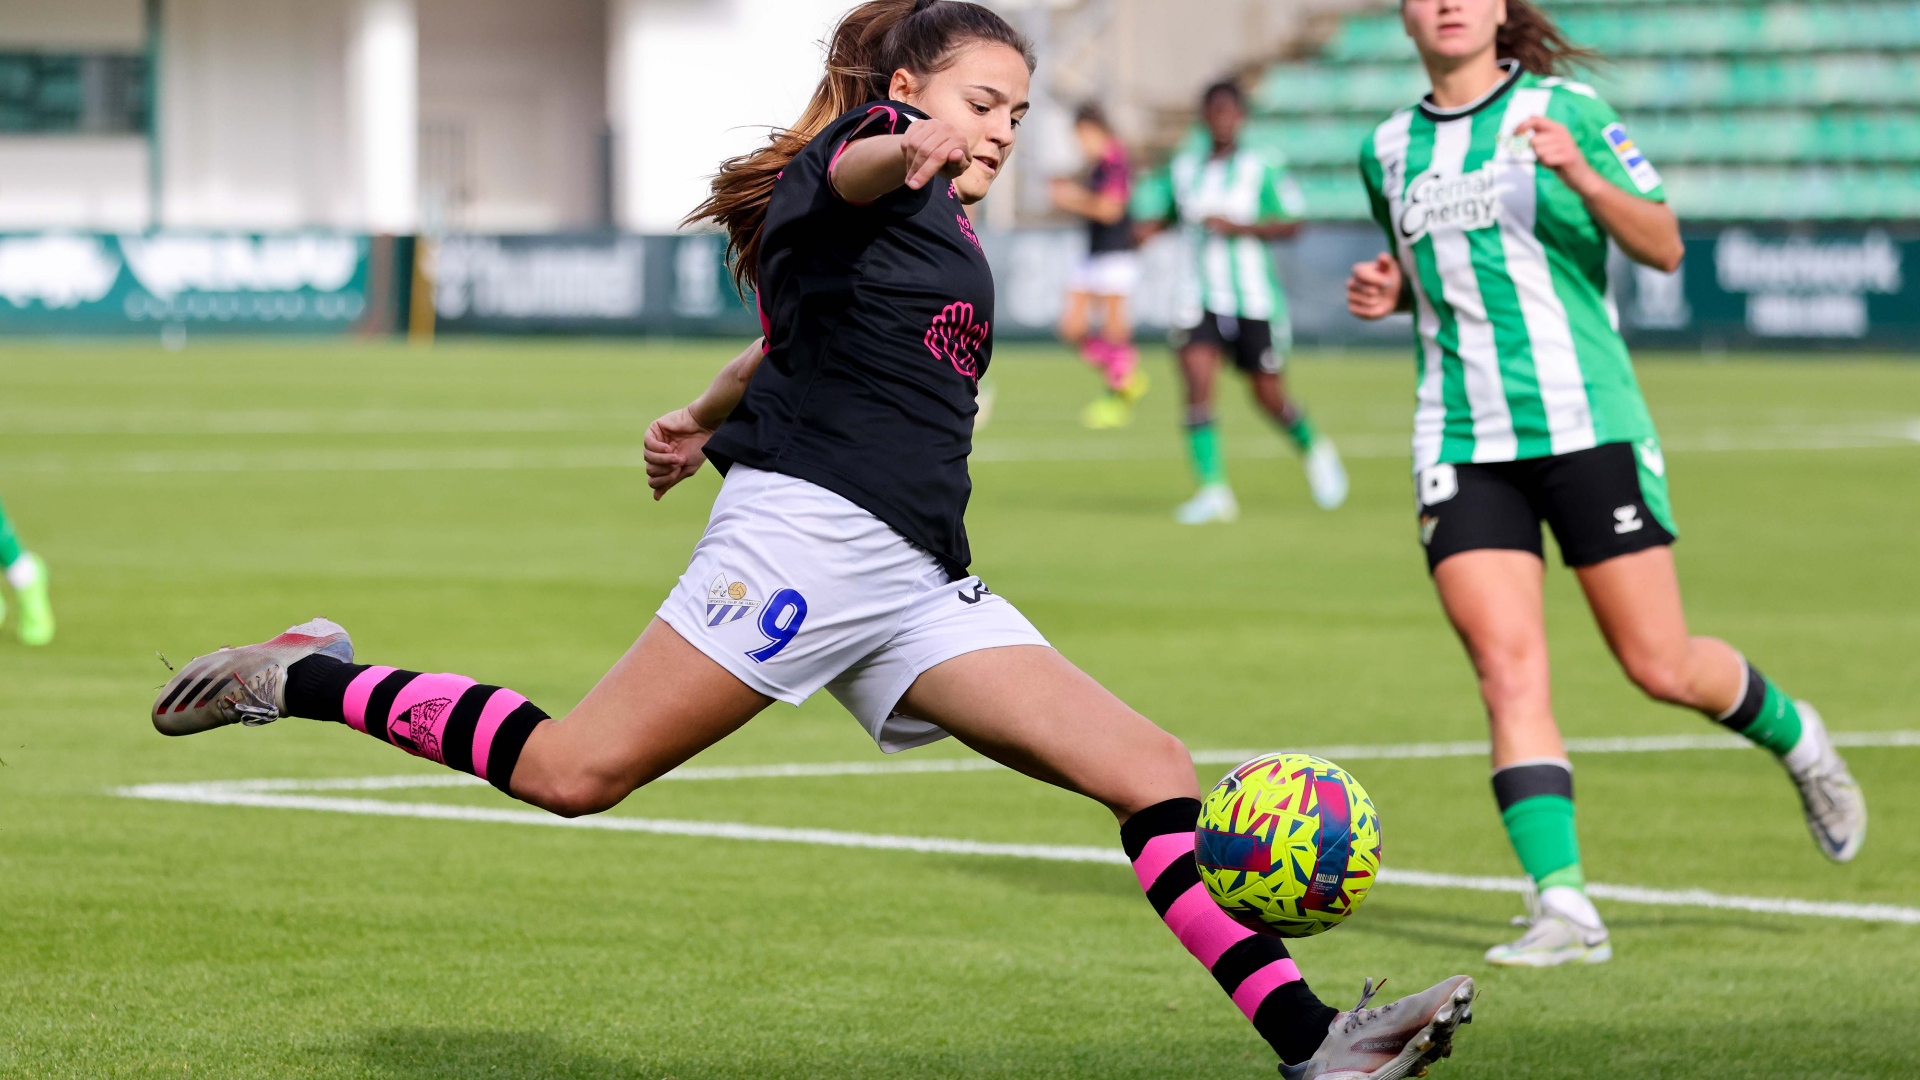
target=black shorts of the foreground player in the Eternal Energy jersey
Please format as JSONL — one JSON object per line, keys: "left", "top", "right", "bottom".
{"left": 1415, "top": 438, "right": 1678, "bottom": 571}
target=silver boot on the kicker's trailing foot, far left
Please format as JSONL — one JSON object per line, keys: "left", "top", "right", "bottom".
{"left": 154, "top": 619, "right": 353, "bottom": 734}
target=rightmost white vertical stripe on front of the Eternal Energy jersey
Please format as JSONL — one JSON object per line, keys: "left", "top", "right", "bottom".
{"left": 1500, "top": 88, "right": 1597, "bottom": 454}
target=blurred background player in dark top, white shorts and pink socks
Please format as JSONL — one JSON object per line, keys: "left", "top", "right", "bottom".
{"left": 1054, "top": 104, "right": 1146, "bottom": 429}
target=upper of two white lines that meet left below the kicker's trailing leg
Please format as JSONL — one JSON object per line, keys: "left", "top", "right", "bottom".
{"left": 121, "top": 730, "right": 1920, "bottom": 799}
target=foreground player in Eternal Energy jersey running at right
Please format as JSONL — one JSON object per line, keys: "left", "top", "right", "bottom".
{"left": 1348, "top": 0, "right": 1866, "bottom": 967}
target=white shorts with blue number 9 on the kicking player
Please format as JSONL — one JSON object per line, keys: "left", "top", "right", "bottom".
{"left": 659, "top": 465, "right": 1046, "bottom": 753}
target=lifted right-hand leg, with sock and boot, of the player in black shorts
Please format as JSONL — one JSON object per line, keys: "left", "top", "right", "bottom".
{"left": 1576, "top": 548, "right": 1866, "bottom": 863}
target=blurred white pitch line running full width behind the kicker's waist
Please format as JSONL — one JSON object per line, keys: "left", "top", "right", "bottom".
{"left": 0, "top": 419, "right": 1920, "bottom": 475}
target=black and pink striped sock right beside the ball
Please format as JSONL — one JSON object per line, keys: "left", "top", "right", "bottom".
{"left": 1119, "top": 799, "right": 1338, "bottom": 1065}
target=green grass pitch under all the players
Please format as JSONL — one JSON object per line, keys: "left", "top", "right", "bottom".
{"left": 0, "top": 342, "right": 1920, "bottom": 1080}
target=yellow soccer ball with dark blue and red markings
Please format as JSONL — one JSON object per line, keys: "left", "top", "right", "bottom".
{"left": 1194, "top": 753, "right": 1380, "bottom": 938}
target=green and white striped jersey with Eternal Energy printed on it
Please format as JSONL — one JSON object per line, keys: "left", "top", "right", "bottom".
{"left": 1359, "top": 61, "right": 1667, "bottom": 469}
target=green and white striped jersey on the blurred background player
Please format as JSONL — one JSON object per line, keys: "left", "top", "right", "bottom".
{"left": 1133, "top": 146, "right": 1306, "bottom": 327}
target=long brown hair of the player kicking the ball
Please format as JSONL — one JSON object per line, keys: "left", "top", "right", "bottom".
{"left": 685, "top": 0, "right": 1035, "bottom": 294}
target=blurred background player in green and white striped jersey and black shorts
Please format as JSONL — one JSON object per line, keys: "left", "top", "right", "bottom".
{"left": 1135, "top": 83, "right": 1346, "bottom": 525}
